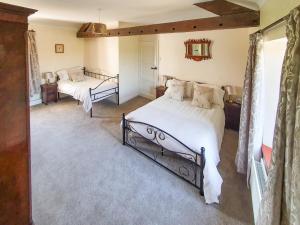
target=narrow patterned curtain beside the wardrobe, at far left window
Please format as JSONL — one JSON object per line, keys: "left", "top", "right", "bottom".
{"left": 27, "top": 31, "right": 41, "bottom": 97}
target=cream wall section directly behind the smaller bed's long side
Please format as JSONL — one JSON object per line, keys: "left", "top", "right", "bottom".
{"left": 84, "top": 37, "right": 119, "bottom": 75}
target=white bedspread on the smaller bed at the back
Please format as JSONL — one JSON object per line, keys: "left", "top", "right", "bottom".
{"left": 58, "top": 76, "right": 117, "bottom": 112}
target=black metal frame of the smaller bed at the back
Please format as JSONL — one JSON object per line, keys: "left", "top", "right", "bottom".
{"left": 58, "top": 67, "right": 120, "bottom": 118}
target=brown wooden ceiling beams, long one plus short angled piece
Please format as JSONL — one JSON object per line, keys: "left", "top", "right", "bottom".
{"left": 77, "top": 0, "right": 260, "bottom": 38}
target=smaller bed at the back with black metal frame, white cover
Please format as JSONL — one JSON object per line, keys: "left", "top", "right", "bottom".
{"left": 57, "top": 68, "right": 119, "bottom": 117}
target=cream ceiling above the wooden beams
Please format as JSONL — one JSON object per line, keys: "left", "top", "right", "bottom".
{"left": 2, "top": 0, "right": 265, "bottom": 27}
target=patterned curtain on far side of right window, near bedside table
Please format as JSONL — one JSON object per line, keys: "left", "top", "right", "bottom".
{"left": 235, "top": 33, "right": 263, "bottom": 181}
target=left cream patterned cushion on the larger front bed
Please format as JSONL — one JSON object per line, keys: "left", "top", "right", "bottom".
{"left": 165, "top": 79, "right": 185, "bottom": 101}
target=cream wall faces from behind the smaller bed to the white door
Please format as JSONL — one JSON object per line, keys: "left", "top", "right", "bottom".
{"left": 84, "top": 36, "right": 139, "bottom": 104}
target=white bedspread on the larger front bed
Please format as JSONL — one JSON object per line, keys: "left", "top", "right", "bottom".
{"left": 126, "top": 96, "right": 225, "bottom": 204}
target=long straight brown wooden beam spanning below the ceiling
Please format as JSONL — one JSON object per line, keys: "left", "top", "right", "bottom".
{"left": 99, "top": 11, "right": 260, "bottom": 37}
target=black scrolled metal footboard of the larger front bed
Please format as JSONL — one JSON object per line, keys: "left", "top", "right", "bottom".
{"left": 122, "top": 114, "right": 205, "bottom": 196}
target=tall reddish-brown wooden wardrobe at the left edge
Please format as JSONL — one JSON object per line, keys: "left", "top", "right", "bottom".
{"left": 0, "top": 2, "right": 36, "bottom": 225}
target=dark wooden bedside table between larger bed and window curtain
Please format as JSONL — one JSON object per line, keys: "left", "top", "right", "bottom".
{"left": 224, "top": 102, "right": 241, "bottom": 131}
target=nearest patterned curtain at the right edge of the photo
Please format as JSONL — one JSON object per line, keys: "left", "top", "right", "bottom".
{"left": 257, "top": 7, "right": 300, "bottom": 225}
